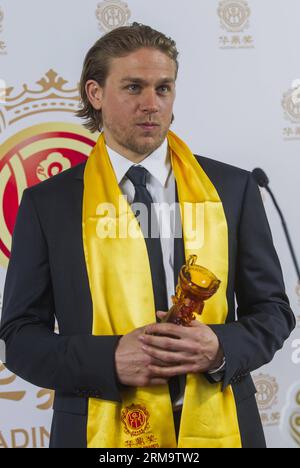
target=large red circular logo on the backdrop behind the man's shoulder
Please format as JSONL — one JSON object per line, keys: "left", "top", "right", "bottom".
{"left": 0, "top": 123, "right": 95, "bottom": 267}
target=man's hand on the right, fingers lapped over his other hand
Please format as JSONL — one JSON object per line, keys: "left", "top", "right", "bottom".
{"left": 138, "top": 312, "right": 224, "bottom": 379}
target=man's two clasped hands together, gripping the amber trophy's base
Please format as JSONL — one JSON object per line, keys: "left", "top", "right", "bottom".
{"left": 115, "top": 312, "right": 224, "bottom": 387}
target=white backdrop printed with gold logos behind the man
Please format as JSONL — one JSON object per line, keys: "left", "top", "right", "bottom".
{"left": 0, "top": 0, "right": 300, "bottom": 447}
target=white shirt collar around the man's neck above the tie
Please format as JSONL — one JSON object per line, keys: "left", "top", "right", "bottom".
{"left": 106, "top": 139, "right": 171, "bottom": 187}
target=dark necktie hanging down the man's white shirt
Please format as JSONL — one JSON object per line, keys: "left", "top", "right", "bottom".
{"left": 126, "top": 166, "right": 180, "bottom": 402}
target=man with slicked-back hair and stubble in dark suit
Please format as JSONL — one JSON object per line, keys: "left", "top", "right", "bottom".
{"left": 0, "top": 24, "right": 295, "bottom": 448}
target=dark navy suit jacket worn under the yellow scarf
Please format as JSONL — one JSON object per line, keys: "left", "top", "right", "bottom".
{"left": 0, "top": 156, "right": 295, "bottom": 447}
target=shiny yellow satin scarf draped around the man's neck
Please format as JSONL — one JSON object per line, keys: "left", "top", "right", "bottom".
{"left": 82, "top": 132, "right": 241, "bottom": 448}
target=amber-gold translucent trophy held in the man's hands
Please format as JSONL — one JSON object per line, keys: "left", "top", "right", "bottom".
{"left": 162, "top": 255, "right": 221, "bottom": 327}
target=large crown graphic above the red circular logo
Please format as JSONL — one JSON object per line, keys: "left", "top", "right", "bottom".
{"left": 0, "top": 69, "right": 80, "bottom": 133}
